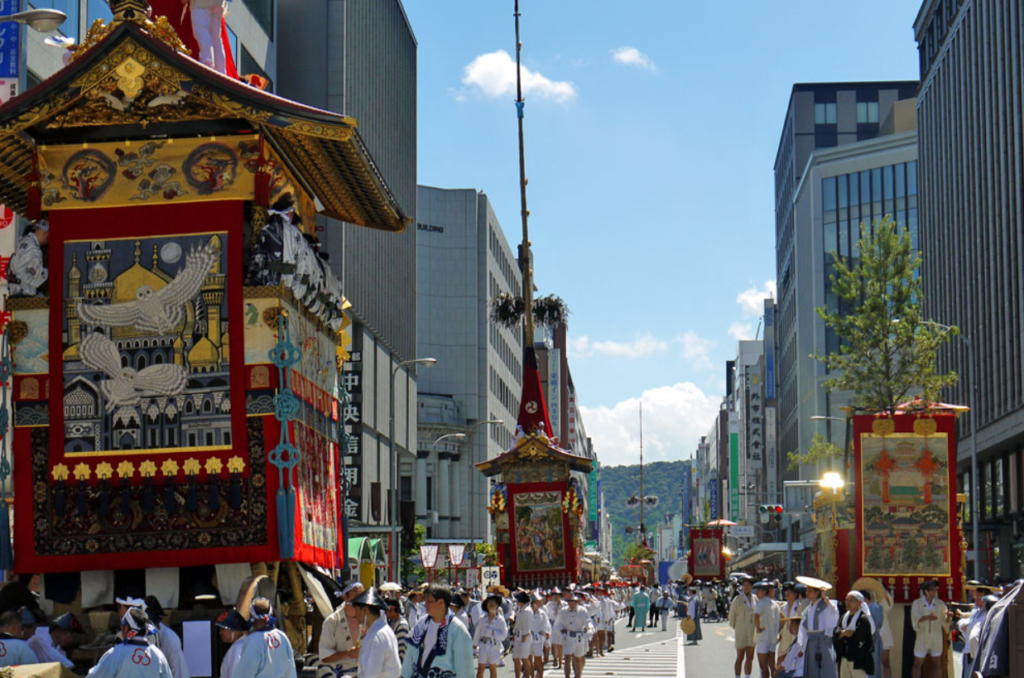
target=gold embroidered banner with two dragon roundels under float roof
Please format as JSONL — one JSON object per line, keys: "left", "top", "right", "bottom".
{"left": 39, "top": 134, "right": 260, "bottom": 212}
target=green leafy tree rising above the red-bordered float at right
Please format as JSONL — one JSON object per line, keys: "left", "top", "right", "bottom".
{"left": 814, "top": 217, "right": 958, "bottom": 414}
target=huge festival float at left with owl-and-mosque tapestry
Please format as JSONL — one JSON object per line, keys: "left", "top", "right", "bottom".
{"left": 0, "top": 0, "right": 409, "bottom": 649}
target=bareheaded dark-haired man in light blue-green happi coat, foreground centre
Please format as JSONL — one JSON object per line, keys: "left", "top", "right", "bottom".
{"left": 401, "top": 584, "right": 476, "bottom": 678}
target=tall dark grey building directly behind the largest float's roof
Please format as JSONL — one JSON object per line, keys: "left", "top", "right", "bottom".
{"left": 274, "top": 0, "right": 417, "bottom": 551}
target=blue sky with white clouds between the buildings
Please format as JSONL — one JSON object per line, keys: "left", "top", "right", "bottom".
{"left": 404, "top": 0, "right": 921, "bottom": 464}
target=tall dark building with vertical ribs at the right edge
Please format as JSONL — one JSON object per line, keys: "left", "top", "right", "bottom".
{"left": 914, "top": 0, "right": 1024, "bottom": 580}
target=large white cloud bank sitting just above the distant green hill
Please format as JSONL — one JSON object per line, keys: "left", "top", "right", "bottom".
{"left": 581, "top": 382, "right": 721, "bottom": 471}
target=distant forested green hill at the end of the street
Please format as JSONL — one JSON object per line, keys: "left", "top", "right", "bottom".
{"left": 601, "top": 461, "right": 683, "bottom": 567}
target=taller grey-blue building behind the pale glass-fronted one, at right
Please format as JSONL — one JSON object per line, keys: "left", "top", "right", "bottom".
{"left": 775, "top": 81, "right": 918, "bottom": 471}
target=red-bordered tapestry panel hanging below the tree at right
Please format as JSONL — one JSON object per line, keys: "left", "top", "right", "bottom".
{"left": 854, "top": 410, "right": 962, "bottom": 602}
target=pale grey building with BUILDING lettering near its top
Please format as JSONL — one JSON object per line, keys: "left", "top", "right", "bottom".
{"left": 413, "top": 186, "right": 522, "bottom": 541}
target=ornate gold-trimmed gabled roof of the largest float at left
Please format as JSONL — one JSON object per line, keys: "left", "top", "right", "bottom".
{"left": 0, "top": 17, "right": 411, "bottom": 231}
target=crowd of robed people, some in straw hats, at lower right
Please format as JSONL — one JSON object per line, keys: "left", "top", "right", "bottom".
{"left": 677, "top": 574, "right": 1024, "bottom": 678}
